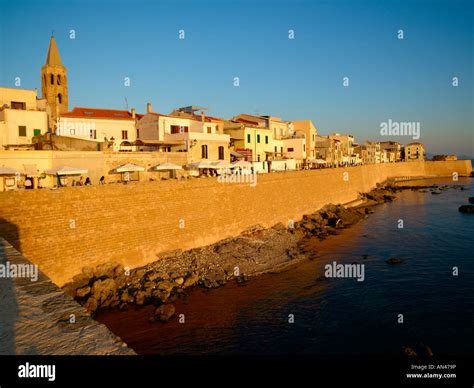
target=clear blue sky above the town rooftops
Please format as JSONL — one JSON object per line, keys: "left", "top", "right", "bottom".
{"left": 0, "top": 0, "right": 474, "bottom": 157}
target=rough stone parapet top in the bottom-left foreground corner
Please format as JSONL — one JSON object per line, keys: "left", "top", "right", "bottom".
{"left": 0, "top": 238, "right": 135, "bottom": 355}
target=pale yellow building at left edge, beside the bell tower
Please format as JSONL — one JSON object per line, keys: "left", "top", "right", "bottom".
{"left": 0, "top": 88, "right": 48, "bottom": 149}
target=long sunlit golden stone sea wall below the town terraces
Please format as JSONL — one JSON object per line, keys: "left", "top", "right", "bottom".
{"left": 0, "top": 161, "right": 472, "bottom": 286}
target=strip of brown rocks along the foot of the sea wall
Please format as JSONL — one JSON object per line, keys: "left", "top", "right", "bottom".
{"left": 64, "top": 180, "right": 466, "bottom": 322}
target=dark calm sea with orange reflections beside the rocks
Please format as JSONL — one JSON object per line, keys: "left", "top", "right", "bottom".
{"left": 98, "top": 178, "right": 474, "bottom": 355}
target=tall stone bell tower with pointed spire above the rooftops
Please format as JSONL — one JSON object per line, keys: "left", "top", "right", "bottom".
{"left": 41, "top": 35, "right": 68, "bottom": 131}
